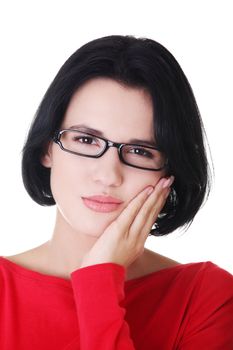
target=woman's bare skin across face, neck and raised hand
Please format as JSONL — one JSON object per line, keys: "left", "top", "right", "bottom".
{"left": 15, "top": 78, "right": 173, "bottom": 278}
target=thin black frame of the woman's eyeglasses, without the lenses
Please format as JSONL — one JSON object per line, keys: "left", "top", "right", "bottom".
{"left": 53, "top": 129, "right": 168, "bottom": 171}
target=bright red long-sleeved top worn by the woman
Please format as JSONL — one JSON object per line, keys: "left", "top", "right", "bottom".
{"left": 0, "top": 257, "right": 233, "bottom": 350}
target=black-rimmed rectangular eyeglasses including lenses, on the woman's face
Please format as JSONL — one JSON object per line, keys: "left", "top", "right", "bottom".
{"left": 53, "top": 129, "right": 167, "bottom": 171}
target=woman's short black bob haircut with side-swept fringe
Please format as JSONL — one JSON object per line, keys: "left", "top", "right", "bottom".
{"left": 22, "top": 35, "right": 211, "bottom": 236}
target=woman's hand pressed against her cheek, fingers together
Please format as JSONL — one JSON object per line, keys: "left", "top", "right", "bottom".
{"left": 81, "top": 176, "right": 174, "bottom": 268}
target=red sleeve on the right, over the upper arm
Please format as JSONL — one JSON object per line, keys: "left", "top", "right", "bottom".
{"left": 178, "top": 265, "right": 233, "bottom": 350}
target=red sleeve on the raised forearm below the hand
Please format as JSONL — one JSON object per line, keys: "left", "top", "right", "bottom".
{"left": 71, "top": 263, "right": 135, "bottom": 350}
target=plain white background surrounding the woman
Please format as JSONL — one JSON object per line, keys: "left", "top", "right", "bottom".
{"left": 0, "top": 0, "right": 233, "bottom": 273}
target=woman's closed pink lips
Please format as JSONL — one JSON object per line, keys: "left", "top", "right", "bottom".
{"left": 82, "top": 196, "right": 122, "bottom": 213}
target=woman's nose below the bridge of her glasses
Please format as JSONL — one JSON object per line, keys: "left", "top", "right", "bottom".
{"left": 92, "top": 147, "right": 124, "bottom": 187}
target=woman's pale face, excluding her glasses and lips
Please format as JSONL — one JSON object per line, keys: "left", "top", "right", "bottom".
{"left": 42, "top": 78, "right": 164, "bottom": 237}
